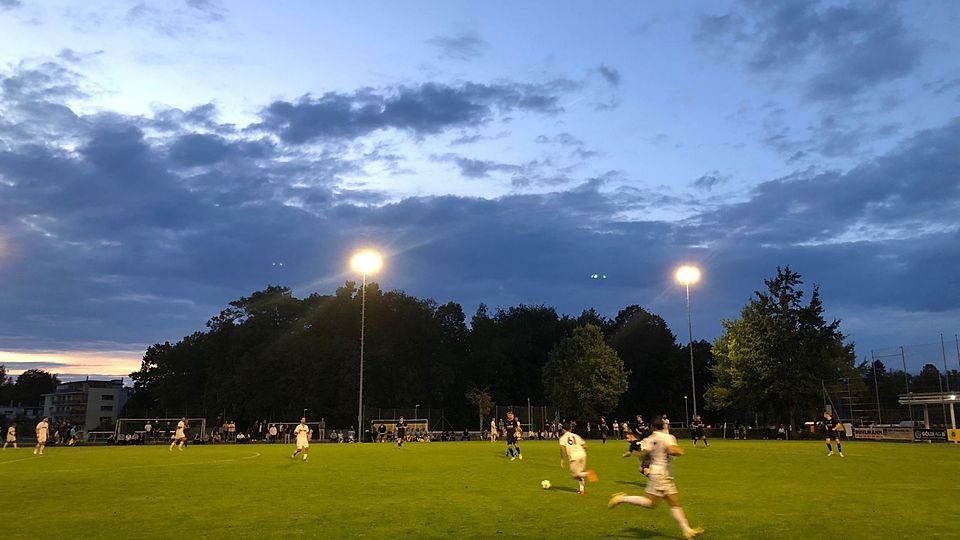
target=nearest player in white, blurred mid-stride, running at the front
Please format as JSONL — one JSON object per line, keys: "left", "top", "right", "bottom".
{"left": 607, "top": 418, "right": 703, "bottom": 538}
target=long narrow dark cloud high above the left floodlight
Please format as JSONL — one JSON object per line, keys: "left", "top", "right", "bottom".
{"left": 256, "top": 81, "right": 574, "bottom": 144}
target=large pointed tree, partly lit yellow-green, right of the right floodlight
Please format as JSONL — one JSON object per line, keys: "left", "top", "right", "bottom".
{"left": 707, "top": 267, "right": 855, "bottom": 426}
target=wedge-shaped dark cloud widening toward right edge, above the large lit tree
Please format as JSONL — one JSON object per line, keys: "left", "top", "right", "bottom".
{"left": 699, "top": 119, "right": 960, "bottom": 250}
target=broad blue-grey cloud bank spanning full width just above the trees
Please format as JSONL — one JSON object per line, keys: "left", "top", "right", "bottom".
{"left": 0, "top": 58, "right": 960, "bottom": 372}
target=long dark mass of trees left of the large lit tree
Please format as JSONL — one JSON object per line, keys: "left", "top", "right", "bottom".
{"left": 124, "top": 281, "right": 711, "bottom": 427}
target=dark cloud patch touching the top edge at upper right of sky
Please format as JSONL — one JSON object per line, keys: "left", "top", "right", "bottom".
{"left": 695, "top": 0, "right": 924, "bottom": 100}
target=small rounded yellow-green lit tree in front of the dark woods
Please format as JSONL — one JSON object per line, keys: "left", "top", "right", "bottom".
{"left": 543, "top": 324, "right": 627, "bottom": 420}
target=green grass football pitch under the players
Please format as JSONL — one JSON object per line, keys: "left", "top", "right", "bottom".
{"left": 0, "top": 440, "right": 960, "bottom": 539}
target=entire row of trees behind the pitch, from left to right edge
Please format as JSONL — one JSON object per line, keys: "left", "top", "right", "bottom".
{"left": 0, "top": 267, "right": 944, "bottom": 429}
